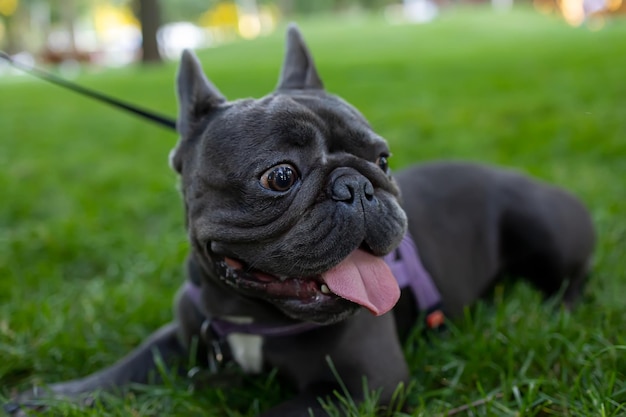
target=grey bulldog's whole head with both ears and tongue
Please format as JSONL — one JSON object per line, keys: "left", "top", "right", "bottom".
{"left": 171, "top": 25, "right": 407, "bottom": 323}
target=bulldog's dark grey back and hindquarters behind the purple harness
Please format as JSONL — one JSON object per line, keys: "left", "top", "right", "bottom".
{"left": 396, "top": 162, "right": 595, "bottom": 315}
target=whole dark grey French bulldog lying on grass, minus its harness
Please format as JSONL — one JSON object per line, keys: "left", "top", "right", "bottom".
{"left": 8, "top": 27, "right": 594, "bottom": 416}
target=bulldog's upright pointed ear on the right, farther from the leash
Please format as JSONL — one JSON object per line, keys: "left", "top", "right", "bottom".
{"left": 276, "top": 23, "right": 324, "bottom": 90}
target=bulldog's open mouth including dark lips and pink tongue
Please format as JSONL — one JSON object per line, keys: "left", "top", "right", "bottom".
{"left": 214, "top": 249, "right": 400, "bottom": 316}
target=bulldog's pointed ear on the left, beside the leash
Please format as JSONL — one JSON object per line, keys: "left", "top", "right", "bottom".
{"left": 176, "top": 49, "right": 226, "bottom": 139}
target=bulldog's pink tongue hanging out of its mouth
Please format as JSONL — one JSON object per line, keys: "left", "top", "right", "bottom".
{"left": 322, "top": 249, "right": 400, "bottom": 316}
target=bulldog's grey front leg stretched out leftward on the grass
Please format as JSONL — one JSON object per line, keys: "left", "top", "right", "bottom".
{"left": 4, "top": 323, "right": 185, "bottom": 416}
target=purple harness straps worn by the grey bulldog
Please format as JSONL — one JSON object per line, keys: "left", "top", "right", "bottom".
{"left": 184, "top": 232, "right": 444, "bottom": 340}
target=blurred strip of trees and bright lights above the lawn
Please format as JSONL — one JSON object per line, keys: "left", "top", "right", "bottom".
{"left": 0, "top": 0, "right": 626, "bottom": 70}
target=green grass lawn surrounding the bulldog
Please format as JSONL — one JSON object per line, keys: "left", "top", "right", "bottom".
{"left": 0, "top": 6, "right": 626, "bottom": 416}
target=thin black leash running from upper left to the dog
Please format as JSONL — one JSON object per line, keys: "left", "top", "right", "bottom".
{"left": 0, "top": 51, "right": 176, "bottom": 130}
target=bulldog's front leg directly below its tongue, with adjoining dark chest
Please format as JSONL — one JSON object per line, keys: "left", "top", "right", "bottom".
{"left": 263, "top": 311, "right": 409, "bottom": 417}
